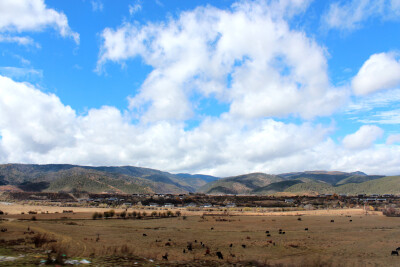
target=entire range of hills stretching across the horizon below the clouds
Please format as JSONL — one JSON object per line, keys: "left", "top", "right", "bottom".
{"left": 0, "top": 164, "right": 400, "bottom": 195}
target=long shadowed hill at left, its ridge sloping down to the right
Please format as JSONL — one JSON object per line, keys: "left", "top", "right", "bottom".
{"left": 0, "top": 164, "right": 214, "bottom": 193}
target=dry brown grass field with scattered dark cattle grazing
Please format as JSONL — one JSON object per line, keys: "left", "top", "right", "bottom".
{"left": 0, "top": 205, "right": 400, "bottom": 266}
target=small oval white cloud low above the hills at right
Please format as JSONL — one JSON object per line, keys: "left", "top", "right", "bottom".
{"left": 343, "top": 125, "right": 383, "bottom": 150}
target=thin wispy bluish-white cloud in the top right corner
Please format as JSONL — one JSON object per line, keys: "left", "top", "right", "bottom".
{"left": 322, "top": 0, "right": 400, "bottom": 30}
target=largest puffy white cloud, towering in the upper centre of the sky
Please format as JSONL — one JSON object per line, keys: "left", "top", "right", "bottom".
{"left": 98, "top": 0, "right": 347, "bottom": 121}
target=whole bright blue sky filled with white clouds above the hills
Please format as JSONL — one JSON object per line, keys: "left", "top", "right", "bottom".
{"left": 0, "top": 0, "right": 400, "bottom": 177}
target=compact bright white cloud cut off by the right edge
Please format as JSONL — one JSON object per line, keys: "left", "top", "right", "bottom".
{"left": 352, "top": 53, "right": 400, "bottom": 95}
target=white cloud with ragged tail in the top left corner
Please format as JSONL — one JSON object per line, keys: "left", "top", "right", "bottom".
{"left": 0, "top": 0, "right": 79, "bottom": 44}
